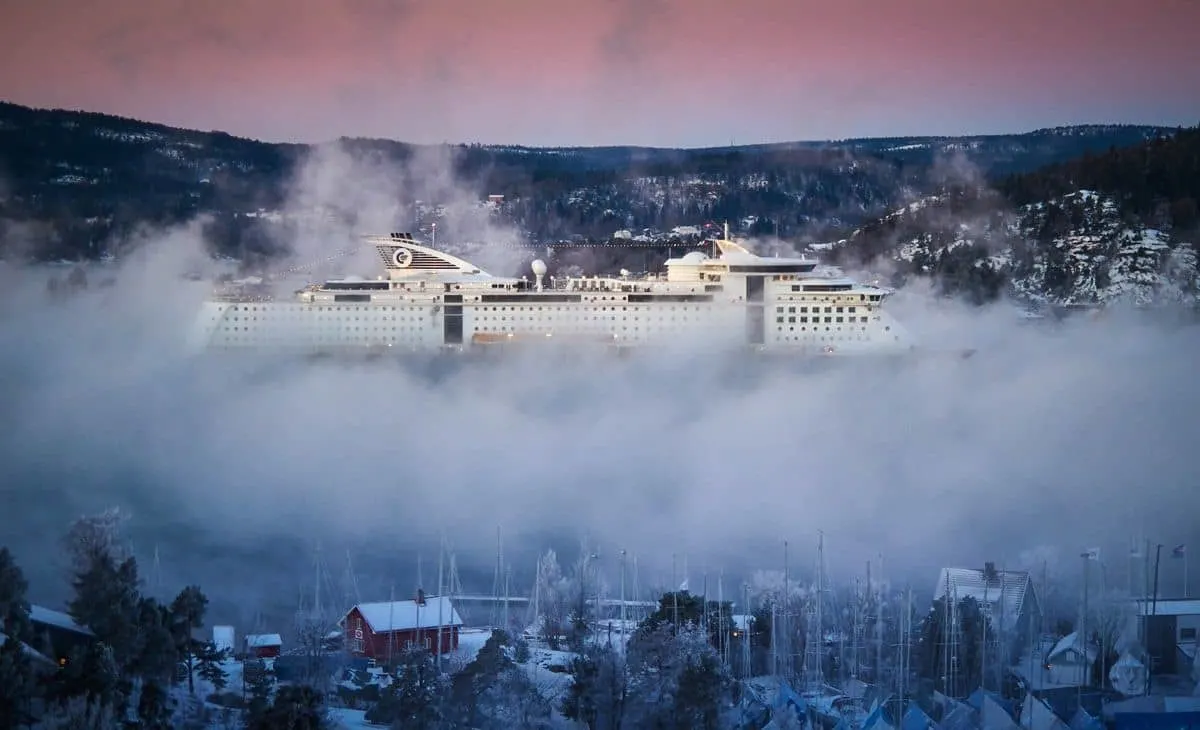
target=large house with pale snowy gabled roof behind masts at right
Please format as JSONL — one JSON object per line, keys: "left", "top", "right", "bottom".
{"left": 934, "top": 563, "right": 1042, "bottom": 662}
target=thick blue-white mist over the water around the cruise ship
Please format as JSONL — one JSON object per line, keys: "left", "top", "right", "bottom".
{"left": 0, "top": 148, "right": 1200, "bottom": 617}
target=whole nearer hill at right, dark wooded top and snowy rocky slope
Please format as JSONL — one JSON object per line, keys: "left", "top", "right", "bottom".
{"left": 830, "top": 127, "right": 1200, "bottom": 306}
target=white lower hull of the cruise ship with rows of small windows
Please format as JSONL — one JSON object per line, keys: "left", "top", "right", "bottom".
{"left": 191, "top": 294, "right": 913, "bottom": 355}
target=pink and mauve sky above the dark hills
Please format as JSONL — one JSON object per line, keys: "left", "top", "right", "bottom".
{"left": 0, "top": 0, "right": 1200, "bottom": 146}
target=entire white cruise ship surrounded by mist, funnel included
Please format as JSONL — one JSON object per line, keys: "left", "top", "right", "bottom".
{"left": 192, "top": 229, "right": 914, "bottom": 357}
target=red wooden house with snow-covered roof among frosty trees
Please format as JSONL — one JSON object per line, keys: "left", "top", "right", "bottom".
{"left": 340, "top": 591, "right": 462, "bottom": 664}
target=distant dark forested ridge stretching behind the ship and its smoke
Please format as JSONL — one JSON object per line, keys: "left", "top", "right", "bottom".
{"left": 0, "top": 103, "right": 1174, "bottom": 259}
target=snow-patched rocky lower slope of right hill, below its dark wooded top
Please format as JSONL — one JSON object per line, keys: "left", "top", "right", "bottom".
{"left": 829, "top": 190, "right": 1200, "bottom": 306}
